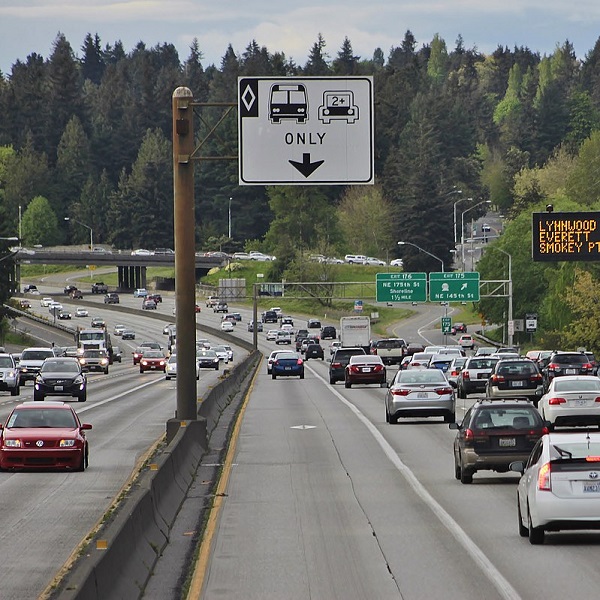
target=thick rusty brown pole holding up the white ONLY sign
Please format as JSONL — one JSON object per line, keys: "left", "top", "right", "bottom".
{"left": 173, "top": 87, "right": 198, "bottom": 421}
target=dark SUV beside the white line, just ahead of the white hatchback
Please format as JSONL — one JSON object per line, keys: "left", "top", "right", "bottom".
{"left": 449, "top": 398, "right": 548, "bottom": 483}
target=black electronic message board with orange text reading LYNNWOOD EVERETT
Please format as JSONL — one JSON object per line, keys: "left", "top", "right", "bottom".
{"left": 531, "top": 212, "right": 600, "bottom": 261}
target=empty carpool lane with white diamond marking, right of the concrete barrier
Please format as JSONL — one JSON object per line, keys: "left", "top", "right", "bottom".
{"left": 203, "top": 369, "right": 506, "bottom": 599}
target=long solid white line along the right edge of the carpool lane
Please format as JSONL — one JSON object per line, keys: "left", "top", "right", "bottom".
{"left": 305, "top": 365, "right": 521, "bottom": 600}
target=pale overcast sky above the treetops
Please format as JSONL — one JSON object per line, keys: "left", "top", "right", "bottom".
{"left": 0, "top": 0, "right": 600, "bottom": 75}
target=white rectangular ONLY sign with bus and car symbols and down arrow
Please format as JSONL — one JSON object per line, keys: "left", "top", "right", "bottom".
{"left": 238, "top": 77, "right": 374, "bottom": 185}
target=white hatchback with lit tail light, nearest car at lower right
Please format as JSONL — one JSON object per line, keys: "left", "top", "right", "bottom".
{"left": 510, "top": 432, "right": 600, "bottom": 544}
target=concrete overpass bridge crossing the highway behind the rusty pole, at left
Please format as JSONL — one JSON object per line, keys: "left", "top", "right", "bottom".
{"left": 11, "top": 249, "right": 226, "bottom": 293}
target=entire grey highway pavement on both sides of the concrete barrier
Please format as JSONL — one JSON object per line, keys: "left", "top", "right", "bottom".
{"left": 7, "top": 282, "right": 600, "bottom": 600}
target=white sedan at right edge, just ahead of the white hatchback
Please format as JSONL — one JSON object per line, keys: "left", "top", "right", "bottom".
{"left": 538, "top": 375, "right": 600, "bottom": 428}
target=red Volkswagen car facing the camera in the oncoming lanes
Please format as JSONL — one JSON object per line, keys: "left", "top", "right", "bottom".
{"left": 0, "top": 401, "right": 92, "bottom": 471}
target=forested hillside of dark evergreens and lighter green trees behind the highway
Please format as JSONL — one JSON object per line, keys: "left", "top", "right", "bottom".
{"left": 0, "top": 31, "right": 600, "bottom": 348}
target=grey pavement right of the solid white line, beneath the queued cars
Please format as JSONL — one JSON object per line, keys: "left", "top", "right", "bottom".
{"left": 339, "top": 387, "right": 600, "bottom": 600}
